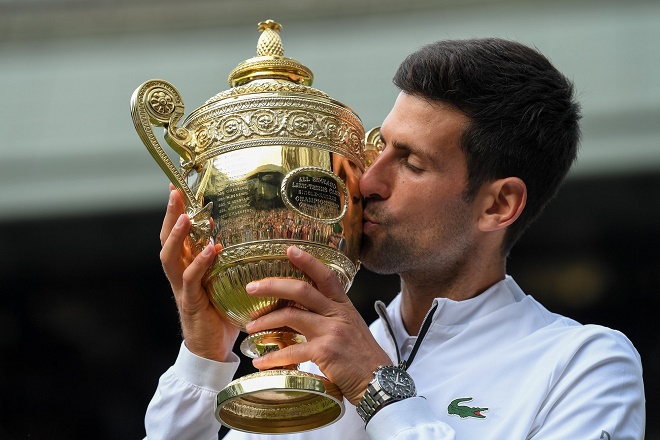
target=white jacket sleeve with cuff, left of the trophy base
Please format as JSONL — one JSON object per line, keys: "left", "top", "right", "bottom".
{"left": 144, "top": 343, "right": 239, "bottom": 440}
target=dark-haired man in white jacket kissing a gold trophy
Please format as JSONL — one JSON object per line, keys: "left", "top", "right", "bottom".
{"left": 146, "top": 39, "right": 645, "bottom": 440}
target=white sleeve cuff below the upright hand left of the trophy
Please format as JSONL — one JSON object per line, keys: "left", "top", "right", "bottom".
{"left": 170, "top": 341, "right": 240, "bottom": 392}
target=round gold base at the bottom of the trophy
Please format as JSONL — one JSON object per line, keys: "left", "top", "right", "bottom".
{"left": 215, "top": 369, "right": 344, "bottom": 434}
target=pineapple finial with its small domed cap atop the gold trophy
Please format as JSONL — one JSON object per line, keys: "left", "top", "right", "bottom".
{"left": 228, "top": 20, "right": 314, "bottom": 87}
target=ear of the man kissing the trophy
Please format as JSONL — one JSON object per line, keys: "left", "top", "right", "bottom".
{"left": 479, "top": 177, "right": 527, "bottom": 232}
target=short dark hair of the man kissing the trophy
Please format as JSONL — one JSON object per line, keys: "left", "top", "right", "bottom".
{"left": 393, "top": 38, "right": 580, "bottom": 255}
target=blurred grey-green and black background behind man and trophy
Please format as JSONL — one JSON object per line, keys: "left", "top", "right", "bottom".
{"left": 0, "top": 0, "right": 660, "bottom": 440}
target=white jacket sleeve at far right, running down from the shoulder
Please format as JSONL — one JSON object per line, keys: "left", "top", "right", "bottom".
{"left": 528, "top": 326, "right": 646, "bottom": 440}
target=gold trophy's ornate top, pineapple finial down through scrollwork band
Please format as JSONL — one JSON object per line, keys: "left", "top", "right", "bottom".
{"left": 178, "top": 20, "right": 365, "bottom": 172}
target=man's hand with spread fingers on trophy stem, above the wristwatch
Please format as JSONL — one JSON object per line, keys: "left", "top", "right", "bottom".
{"left": 246, "top": 247, "right": 392, "bottom": 405}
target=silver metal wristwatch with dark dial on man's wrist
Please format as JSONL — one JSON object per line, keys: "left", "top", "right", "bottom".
{"left": 356, "top": 365, "right": 417, "bottom": 426}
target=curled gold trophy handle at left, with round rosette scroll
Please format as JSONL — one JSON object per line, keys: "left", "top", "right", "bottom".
{"left": 131, "top": 79, "right": 212, "bottom": 250}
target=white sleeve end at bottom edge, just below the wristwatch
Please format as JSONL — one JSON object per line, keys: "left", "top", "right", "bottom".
{"left": 367, "top": 397, "right": 455, "bottom": 440}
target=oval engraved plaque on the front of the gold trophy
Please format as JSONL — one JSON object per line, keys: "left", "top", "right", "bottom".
{"left": 282, "top": 167, "right": 347, "bottom": 224}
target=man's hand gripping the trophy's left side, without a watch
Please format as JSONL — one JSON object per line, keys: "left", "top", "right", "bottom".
{"left": 160, "top": 185, "right": 239, "bottom": 362}
